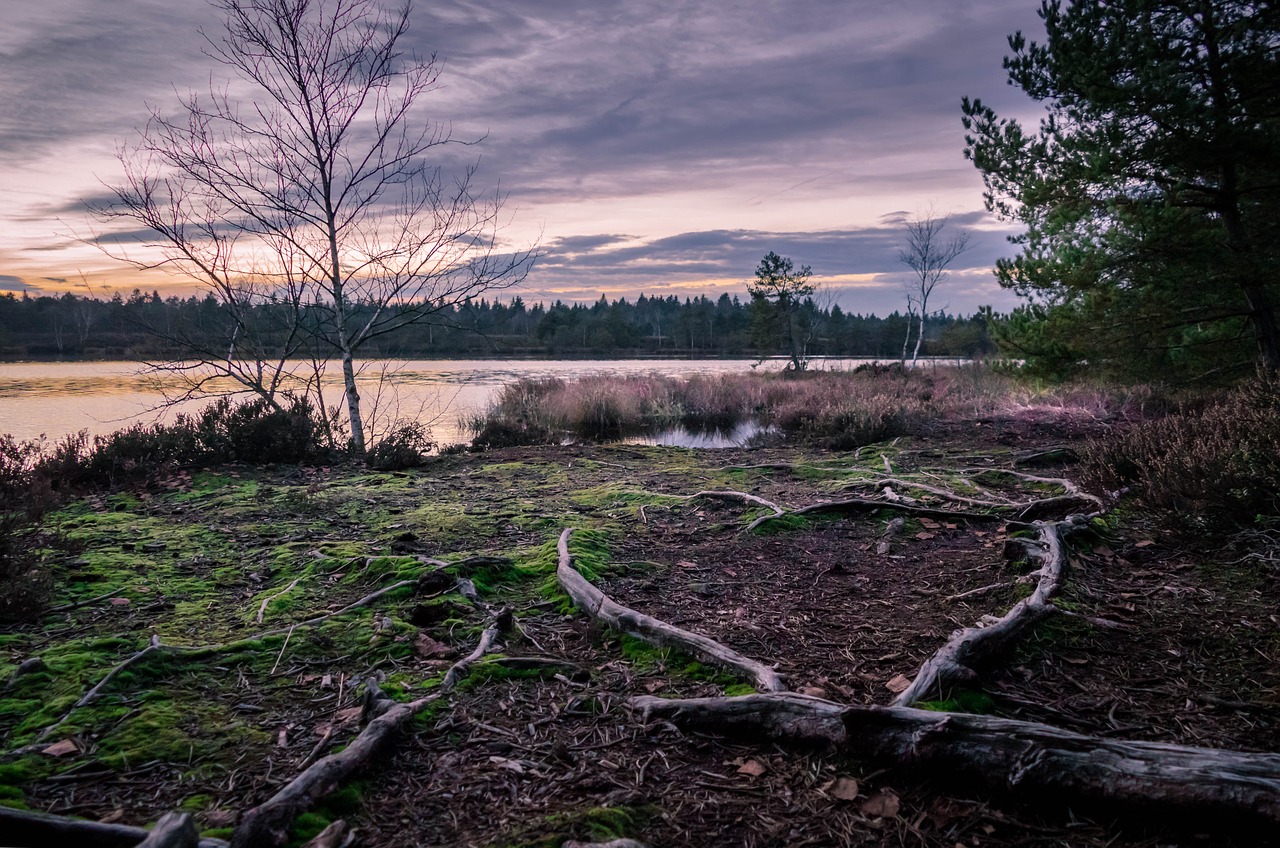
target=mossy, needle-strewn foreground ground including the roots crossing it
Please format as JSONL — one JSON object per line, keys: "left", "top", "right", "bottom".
{"left": 0, "top": 421, "right": 1280, "bottom": 848}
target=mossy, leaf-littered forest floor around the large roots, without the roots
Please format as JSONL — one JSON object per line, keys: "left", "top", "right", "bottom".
{"left": 0, "top": 412, "right": 1280, "bottom": 848}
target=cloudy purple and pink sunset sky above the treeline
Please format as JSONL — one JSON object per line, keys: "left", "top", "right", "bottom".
{"left": 0, "top": 0, "right": 1042, "bottom": 315}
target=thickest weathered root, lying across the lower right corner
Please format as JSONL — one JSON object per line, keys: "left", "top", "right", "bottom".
{"left": 630, "top": 693, "right": 1280, "bottom": 833}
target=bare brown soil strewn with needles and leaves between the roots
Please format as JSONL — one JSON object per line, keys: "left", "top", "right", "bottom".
{"left": 10, "top": 412, "right": 1280, "bottom": 848}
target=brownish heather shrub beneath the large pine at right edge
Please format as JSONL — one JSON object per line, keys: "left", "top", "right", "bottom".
{"left": 1084, "top": 374, "right": 1280, "bottom": 528}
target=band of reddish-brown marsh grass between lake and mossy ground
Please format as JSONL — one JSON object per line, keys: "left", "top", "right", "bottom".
{"left": 467, "top": 365, "right": 1133, "bottom": 450}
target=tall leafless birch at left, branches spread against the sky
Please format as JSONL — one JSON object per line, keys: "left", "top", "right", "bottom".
{"left": 95, "top": 0, "right": 534, "bottom": 453}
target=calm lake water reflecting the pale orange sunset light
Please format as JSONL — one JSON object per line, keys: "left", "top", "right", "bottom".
{"left": 0, "top": 359, "right": 901, "bottom": 447}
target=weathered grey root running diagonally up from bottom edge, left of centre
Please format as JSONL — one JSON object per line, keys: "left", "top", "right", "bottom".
{"left": 230, "top": 615, "right": 502, "bottom": 848}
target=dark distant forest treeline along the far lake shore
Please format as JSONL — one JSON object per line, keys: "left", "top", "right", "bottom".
{"left": 0, "top": 291, "right": 995, "bottom": 360}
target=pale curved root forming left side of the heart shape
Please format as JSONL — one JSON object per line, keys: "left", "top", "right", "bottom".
{"left": 556, "top": 528, "right": 786, "bottom": 692}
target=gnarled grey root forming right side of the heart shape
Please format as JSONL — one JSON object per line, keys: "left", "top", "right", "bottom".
{"left": 893, "top": 516, "right": 1085, "bottom": 707}
